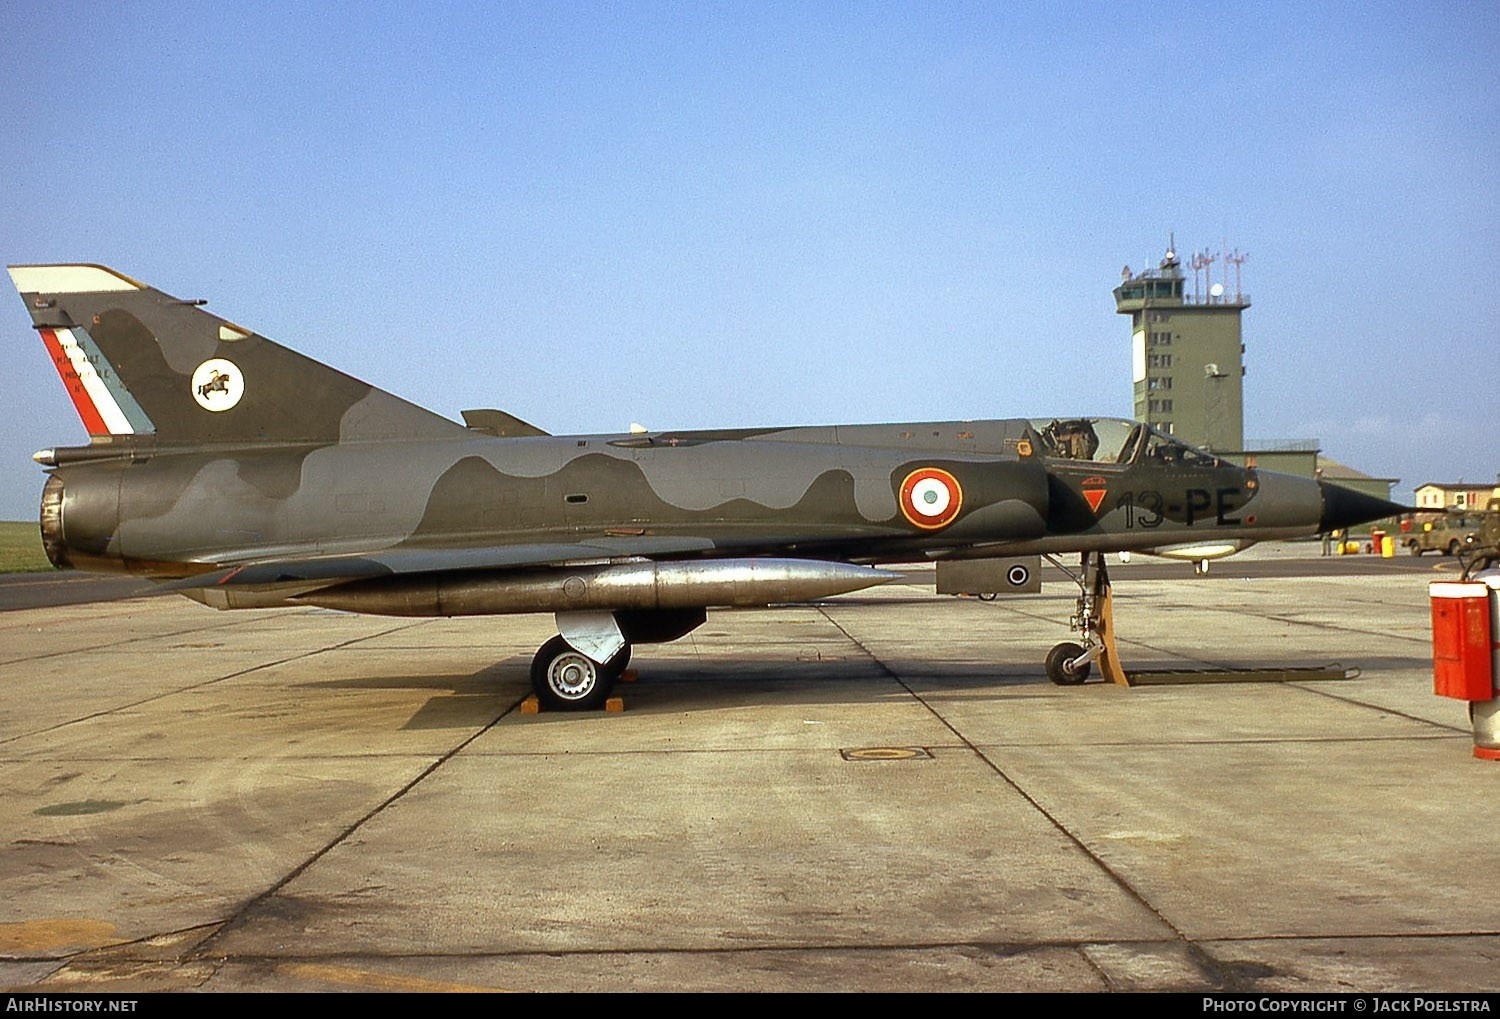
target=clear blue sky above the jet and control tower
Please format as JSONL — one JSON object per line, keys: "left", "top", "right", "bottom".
{"left": 0, "top": 0, "right": 1500, "bottom": 519}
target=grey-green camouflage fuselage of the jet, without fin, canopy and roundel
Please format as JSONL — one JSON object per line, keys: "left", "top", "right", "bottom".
{"left": 41, "top": 420, "right": 1320, "bottom": 576}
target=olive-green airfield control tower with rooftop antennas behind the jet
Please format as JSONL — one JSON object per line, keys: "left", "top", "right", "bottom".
{"left": 1115, "top": 241, "right": 1250, "bottom": 453}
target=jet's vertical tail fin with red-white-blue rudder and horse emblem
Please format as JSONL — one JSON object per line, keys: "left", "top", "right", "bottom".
{"left": 11, "top": 264, "right": 465, "bottom": 444}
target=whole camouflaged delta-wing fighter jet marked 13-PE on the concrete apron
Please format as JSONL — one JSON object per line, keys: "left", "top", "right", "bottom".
{"left": 11, "top": 264, "right": 1401, "bottom": 708}
